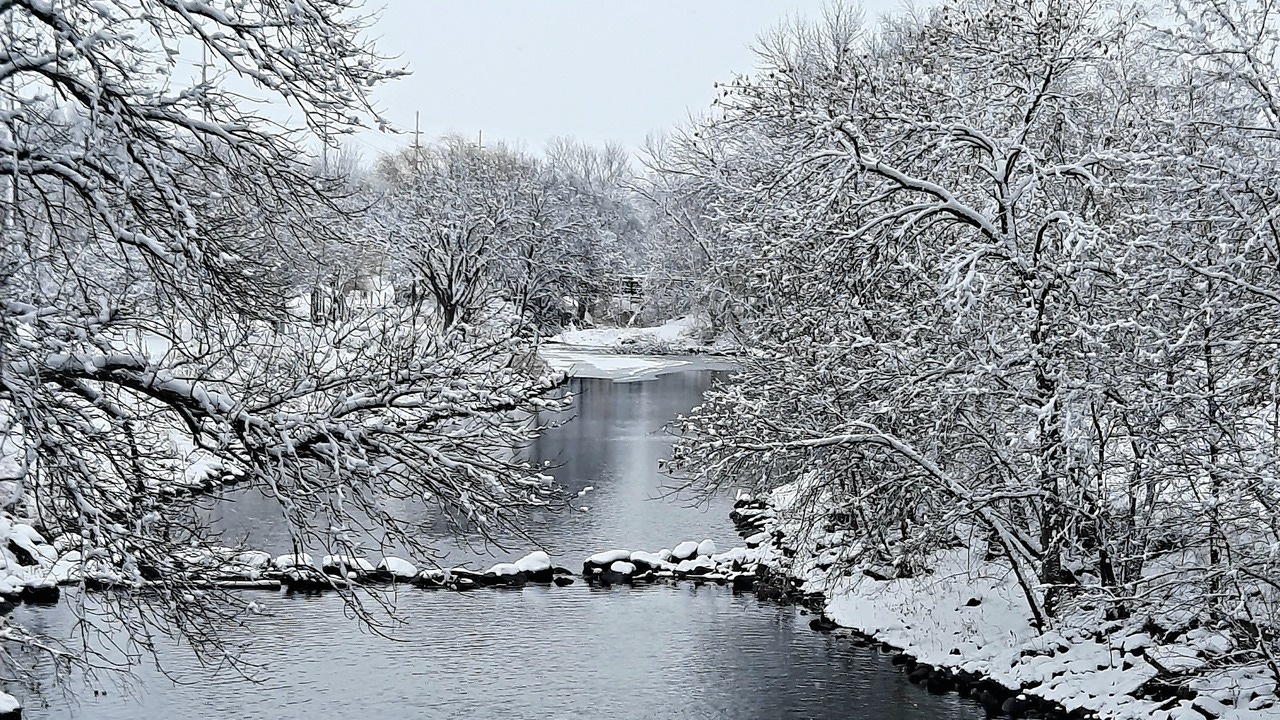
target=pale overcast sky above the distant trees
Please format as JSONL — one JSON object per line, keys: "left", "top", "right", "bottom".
{"left": 356, "top": 0, "right": 900, "bottom": 156}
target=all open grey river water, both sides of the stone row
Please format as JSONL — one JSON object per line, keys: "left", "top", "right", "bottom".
{"left": 19, "top": 370, "right": 979, "bottom": 720}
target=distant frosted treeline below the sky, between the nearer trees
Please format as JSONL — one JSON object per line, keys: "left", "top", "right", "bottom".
{"left": 294, "top": 136, "right": 690, "bottom": 331}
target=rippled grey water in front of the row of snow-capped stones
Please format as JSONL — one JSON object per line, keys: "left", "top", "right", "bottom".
{"left": 22, "top": 584, "right": 977, "bottom": 720}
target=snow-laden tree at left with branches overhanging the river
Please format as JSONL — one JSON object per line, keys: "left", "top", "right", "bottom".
{"left": 0, "top": 0, "right": 557, "bottom": 686}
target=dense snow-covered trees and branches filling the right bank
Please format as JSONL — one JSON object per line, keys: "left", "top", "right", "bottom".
{"left": 655, "top": 0, "right": 1280, "bottom": 670}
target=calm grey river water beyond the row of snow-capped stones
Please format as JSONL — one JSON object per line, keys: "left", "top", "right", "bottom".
{"left": 207, "top": 372, "right": 727, "bottom": 565}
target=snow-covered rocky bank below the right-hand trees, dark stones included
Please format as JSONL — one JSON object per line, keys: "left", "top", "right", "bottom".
{"left": 733, "top": 488, "right": 1280, "bottom": 720}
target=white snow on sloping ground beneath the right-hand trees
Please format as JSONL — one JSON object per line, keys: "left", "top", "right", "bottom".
{"left": 747, "top": 487, "right": 1280, "bottom": 720}
